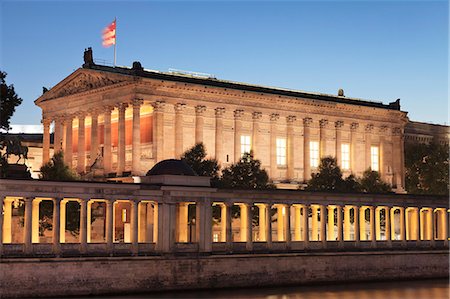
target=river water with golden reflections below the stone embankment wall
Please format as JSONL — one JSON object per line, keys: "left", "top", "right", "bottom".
{"left": 72, "top": 280, "right": 450, "bottom": 299}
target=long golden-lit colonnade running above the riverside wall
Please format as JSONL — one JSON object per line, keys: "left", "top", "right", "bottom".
{"left": 0, "top": 197, "right": 449, "bottom": 254}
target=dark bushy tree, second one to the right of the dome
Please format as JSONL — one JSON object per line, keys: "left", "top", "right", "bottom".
{"left": 219, "top": 153, "right": 274, "bottom": 189}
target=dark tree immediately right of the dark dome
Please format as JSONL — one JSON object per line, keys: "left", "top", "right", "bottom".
{"left": 181, "top": 142, "right": 220, "bottom": 185}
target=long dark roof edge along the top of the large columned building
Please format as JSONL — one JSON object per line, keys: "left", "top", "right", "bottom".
{"left": 83, "top": 62, "right": 400, "bottom": 110}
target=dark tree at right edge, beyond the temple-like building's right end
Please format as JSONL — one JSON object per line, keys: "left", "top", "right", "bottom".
{"left": 405, "top": 142, "right": 449, "bottom": 195}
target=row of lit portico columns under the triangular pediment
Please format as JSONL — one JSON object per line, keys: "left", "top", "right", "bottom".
{"left": 42, "top": 99, "right": 143, "bottom": 175}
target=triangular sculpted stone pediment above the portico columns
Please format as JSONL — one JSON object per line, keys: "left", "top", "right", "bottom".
{"left": 36, "top": 69, "right": 130, "bottom": 104}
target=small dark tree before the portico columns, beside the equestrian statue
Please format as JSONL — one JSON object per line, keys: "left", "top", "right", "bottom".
{"left": 40, "top": 151, "right": 78, "bottom": 181}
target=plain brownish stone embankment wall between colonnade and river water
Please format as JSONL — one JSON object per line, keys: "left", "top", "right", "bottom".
{"left": 0, "top": 250, "right": 449, "bottom": 298}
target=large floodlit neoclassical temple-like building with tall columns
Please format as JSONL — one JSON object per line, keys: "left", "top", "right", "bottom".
{"left": 35, "top": 49, "right": 408, "bottom": 191}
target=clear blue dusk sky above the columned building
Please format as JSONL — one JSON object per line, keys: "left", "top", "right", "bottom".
{"left": 0, "top": 0, "right": 449, "bottom": 124}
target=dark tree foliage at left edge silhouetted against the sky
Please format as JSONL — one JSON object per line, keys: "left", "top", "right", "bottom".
{"left": 0, "top": 71, "right": 22, "bottom": 130}
